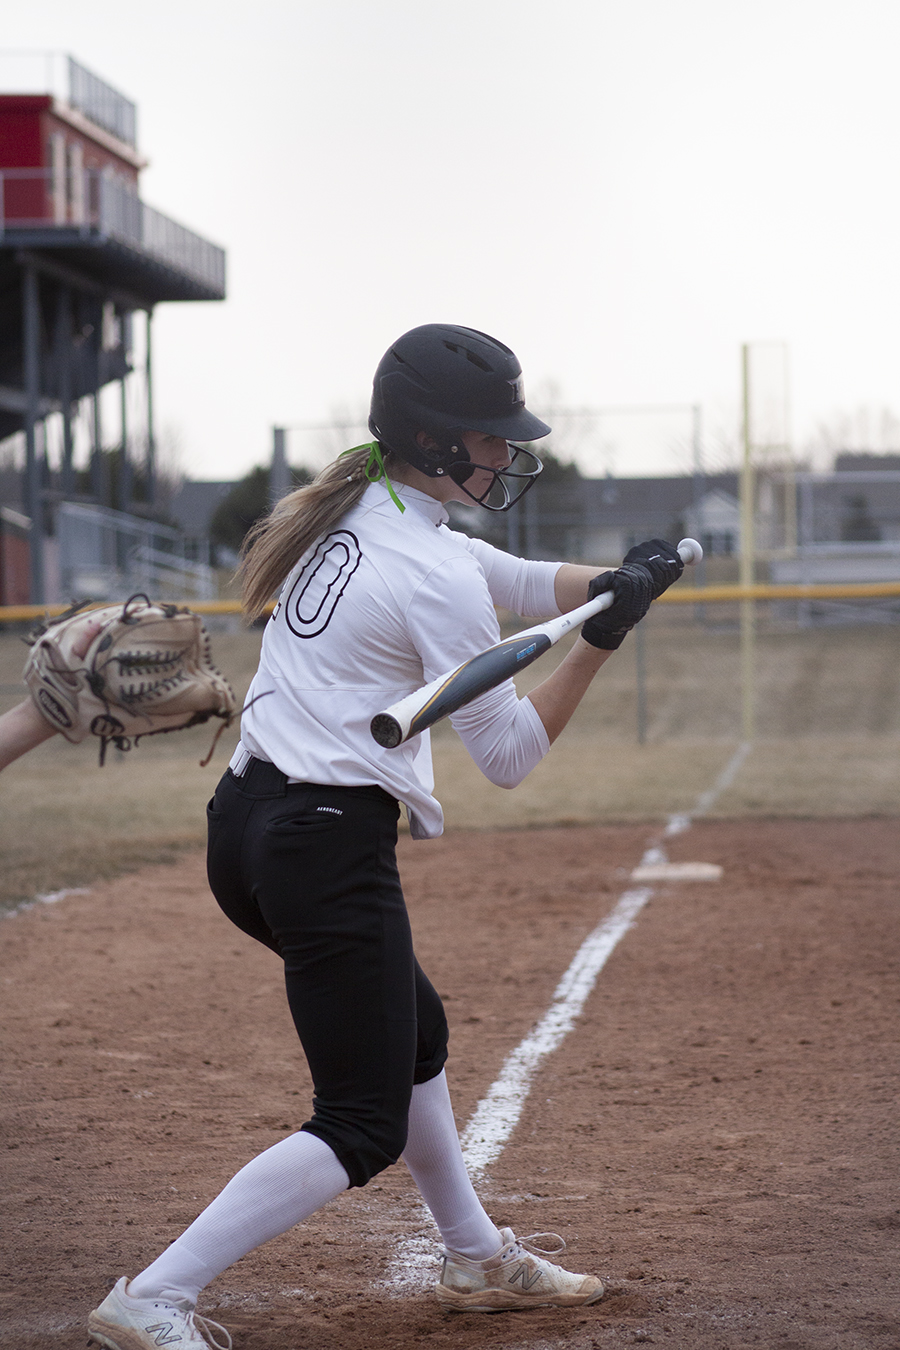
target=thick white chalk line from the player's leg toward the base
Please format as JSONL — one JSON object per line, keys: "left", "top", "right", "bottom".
{"left": 460, "top": 887, "right": 653, "bottom": 1181}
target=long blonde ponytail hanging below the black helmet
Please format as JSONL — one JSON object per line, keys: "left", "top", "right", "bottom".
{"left": 239, "top": 446, "right": 393, "bottom": 620}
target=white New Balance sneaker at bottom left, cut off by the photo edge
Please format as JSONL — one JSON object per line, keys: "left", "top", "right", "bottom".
{"left": 88, "top": 1276, "right": 232, "bottom": 1350}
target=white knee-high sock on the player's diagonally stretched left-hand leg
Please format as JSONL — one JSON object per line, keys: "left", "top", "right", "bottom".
{"left": 128, "top": 1130, "right": 349, "bottom": 1304}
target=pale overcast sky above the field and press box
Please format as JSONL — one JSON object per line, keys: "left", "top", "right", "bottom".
{"left": 3, "top": 0, "right": 900, "bottom": 478}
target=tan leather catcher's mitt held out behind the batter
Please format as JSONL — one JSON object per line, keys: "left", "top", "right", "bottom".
{"left": 24, "top": 595, "right": 235, "bottom": 764}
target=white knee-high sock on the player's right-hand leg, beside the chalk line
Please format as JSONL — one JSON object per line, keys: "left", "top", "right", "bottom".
{"left": 403, "top": 1071, "right": 503, "bottom": 1261}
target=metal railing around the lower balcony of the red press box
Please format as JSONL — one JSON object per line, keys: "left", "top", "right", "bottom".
{"left": 0, "top": 169, "right": 225, "bottom": 294}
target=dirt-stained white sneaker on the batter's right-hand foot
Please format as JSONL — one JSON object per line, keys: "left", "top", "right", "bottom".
{"left": 434, "top": 1229, "right": 603, "bottom": 1312}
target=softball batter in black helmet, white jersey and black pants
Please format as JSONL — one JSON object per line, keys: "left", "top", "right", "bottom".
{"left": 89, "top": 324, "right": 681, "bottom": 1350}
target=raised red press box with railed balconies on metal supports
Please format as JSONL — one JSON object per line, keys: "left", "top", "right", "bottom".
{"left": 0, "top": 54, "right": 225, "bottom": 602}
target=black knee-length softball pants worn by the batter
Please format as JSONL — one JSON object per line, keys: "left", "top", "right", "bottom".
{"left": 208, "top": 760, "right": 447, "bottom": 1185}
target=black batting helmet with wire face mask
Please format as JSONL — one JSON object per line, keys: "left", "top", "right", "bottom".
{"left": 368, "top": 324, "right": 551, "bottom": 512}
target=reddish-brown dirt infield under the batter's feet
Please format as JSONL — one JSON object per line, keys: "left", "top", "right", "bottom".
{"left": 0, "top": 819, "right": 900, "bottom": 1350}
